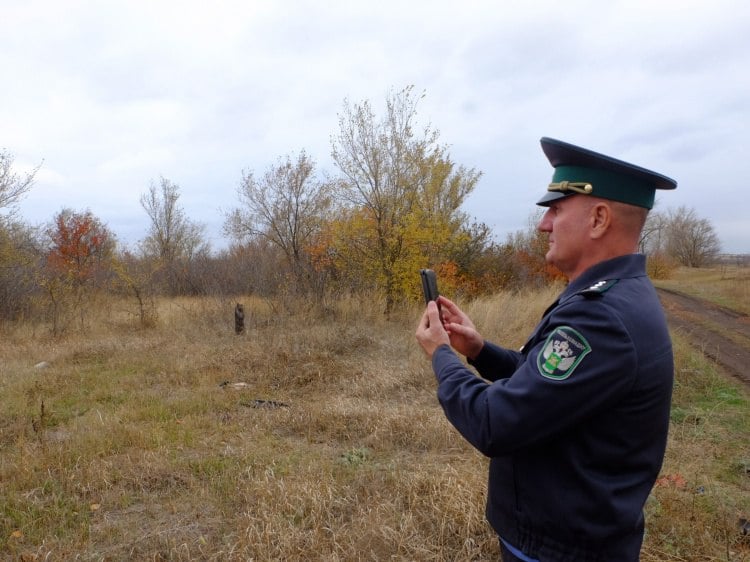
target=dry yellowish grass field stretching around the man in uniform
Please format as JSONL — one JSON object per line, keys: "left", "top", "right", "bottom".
{"left": 0, "top": 272, "right": 750, "bottom": 562}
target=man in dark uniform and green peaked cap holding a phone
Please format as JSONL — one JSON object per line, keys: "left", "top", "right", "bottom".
{"left": 416, "top": 138, "right": 677, "bottom": 562}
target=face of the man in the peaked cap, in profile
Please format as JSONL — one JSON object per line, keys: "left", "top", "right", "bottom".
{"left": 537, "top": 195, "right": 592, "bottom": 279}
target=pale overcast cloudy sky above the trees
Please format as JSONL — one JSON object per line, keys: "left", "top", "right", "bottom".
{"left": 0, "top": 0, "right": 750, "bottom": 253}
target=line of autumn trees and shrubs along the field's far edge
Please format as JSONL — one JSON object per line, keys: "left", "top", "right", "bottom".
{"left": 0, "top": 87, "right": 720, "bottom": 333}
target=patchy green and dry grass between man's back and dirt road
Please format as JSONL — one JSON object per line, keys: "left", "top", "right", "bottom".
{"left": 644, "top": 330, "right": 750, "bottom": 560}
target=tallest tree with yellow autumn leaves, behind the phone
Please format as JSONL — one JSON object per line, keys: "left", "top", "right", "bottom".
{"left": 330, "top": 87, "right": 480, "bottom": 313}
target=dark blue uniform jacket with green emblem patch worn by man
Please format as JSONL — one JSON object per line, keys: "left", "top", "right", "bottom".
{"left": 432, "top": 254, "right": 674, "bottom": 562}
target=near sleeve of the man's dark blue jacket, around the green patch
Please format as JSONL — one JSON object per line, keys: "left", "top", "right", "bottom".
{"left": 433, "top": 301, "right": 637, "bottom": 456}
